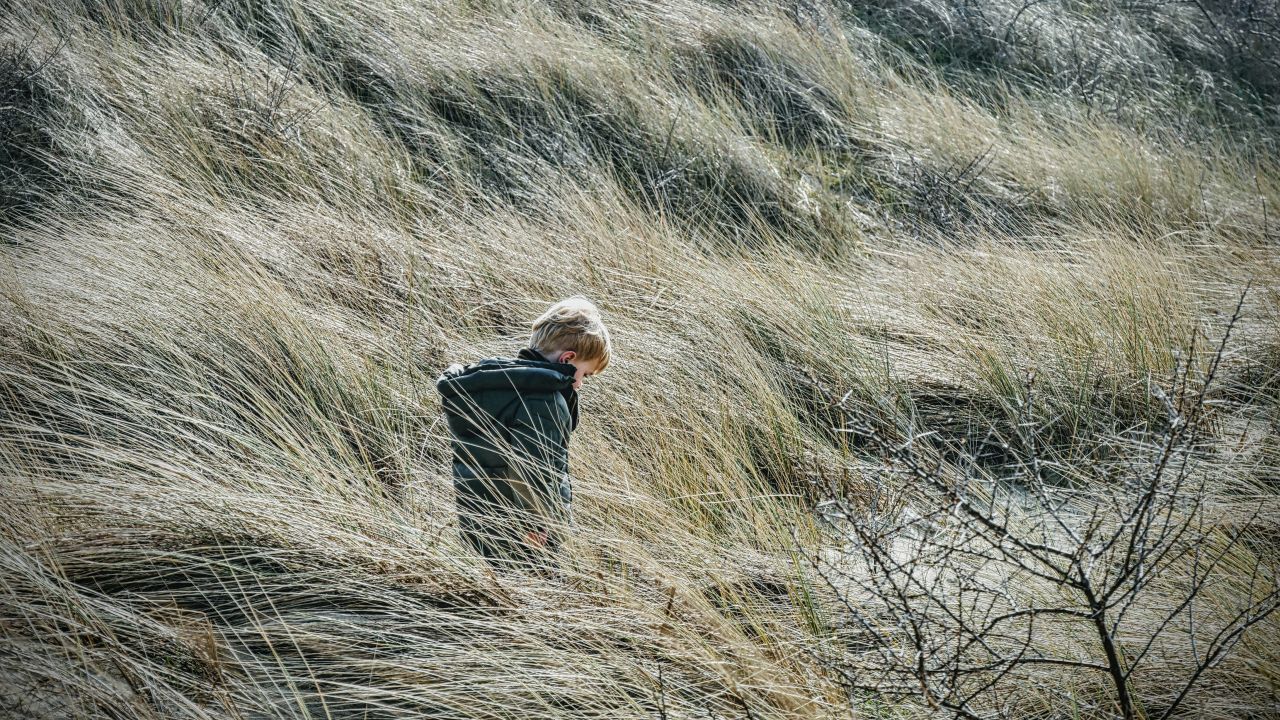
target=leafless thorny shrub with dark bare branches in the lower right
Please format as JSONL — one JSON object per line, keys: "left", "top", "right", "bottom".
{"left": 810, "top": 288, "right": 1280, "bottom": 720}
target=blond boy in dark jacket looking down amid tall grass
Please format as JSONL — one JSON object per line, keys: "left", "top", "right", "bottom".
{"left": 435, "top": 296, "right": 612, "bottom": 565}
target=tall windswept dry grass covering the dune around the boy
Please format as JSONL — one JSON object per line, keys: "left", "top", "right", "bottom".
{"left": 0, "top": 0, "right": 1280, "bottom": 717}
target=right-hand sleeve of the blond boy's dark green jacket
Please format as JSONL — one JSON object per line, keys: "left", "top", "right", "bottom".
{"left": 512, "top": 395, "right": 572, "bottom": 525}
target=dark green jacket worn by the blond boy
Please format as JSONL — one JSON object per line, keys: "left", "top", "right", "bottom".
{"left": 435, "top": 348, "right": 577, "bottom": 534}
